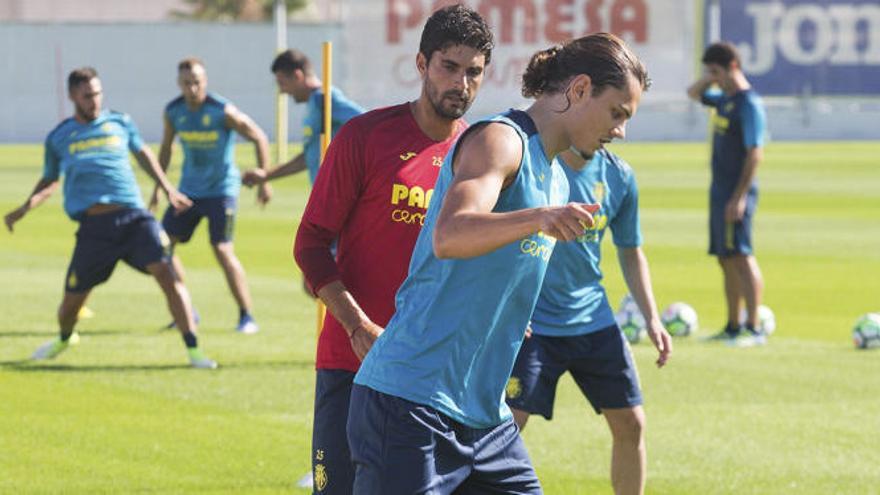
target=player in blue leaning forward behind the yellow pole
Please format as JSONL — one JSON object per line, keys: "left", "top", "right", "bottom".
{"left": 243, "top": 50, "right": 364, "bottom": 185}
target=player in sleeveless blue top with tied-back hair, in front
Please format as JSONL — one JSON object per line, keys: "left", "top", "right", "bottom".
{"left": 348, "top": 33, "right": 647, "bottom": 494}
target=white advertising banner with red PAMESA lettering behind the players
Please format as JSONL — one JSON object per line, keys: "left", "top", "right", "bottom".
{"left": 344, "top": 0, "right": 696, "bottom": 119}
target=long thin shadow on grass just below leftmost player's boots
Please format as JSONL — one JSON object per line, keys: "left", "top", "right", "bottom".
{"left": 0, "top": 359, "right": 315, "bottom": 373}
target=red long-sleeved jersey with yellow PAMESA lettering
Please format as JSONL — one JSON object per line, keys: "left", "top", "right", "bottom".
{"left": 295, "top": 103, "right": 466, "bottom": 371}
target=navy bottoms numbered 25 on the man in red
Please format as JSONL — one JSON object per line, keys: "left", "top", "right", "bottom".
{"left": 312, "top": 369, "right": 354, "bottom": 495}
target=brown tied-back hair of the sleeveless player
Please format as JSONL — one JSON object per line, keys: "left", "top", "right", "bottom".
{"left": 522, "top": 33, "right": 651, "bottom": 98}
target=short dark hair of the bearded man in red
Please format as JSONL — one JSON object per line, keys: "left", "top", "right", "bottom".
{"left": 419, "top": 4, "right": 495, "bottom": 65}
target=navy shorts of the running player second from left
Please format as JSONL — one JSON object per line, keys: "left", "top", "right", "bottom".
{"left": 162, "top": 196, "right": 238, "bottom": 244}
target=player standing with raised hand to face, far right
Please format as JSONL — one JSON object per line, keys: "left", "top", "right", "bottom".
{"left": 688, "top": 42, "right": 767, "bottom": 346}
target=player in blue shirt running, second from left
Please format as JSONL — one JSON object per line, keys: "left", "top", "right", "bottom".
{"left": 150, "top": 58, "right": 271, "bottom": 334}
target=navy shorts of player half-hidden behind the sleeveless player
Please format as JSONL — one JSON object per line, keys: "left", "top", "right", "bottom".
{"left": 507, "top": 325, "right": 642, "bottom": 419}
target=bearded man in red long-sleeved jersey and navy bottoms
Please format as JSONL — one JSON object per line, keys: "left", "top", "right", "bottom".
{"left": 295, "top": 6, "right": 492, "bottom": 494}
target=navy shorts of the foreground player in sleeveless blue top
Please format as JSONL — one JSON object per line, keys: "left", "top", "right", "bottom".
{"left": 348, "top": 385, "right": 543, "bottom": 495}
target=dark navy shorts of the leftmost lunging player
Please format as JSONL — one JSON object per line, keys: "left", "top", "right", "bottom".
{"left": 64, "top": 208, "right": 170, "bottom": 292}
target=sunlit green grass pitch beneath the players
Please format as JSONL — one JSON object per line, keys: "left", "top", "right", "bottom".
{"left": 0, "top": 142, "right": 880, "bottom": 495}
